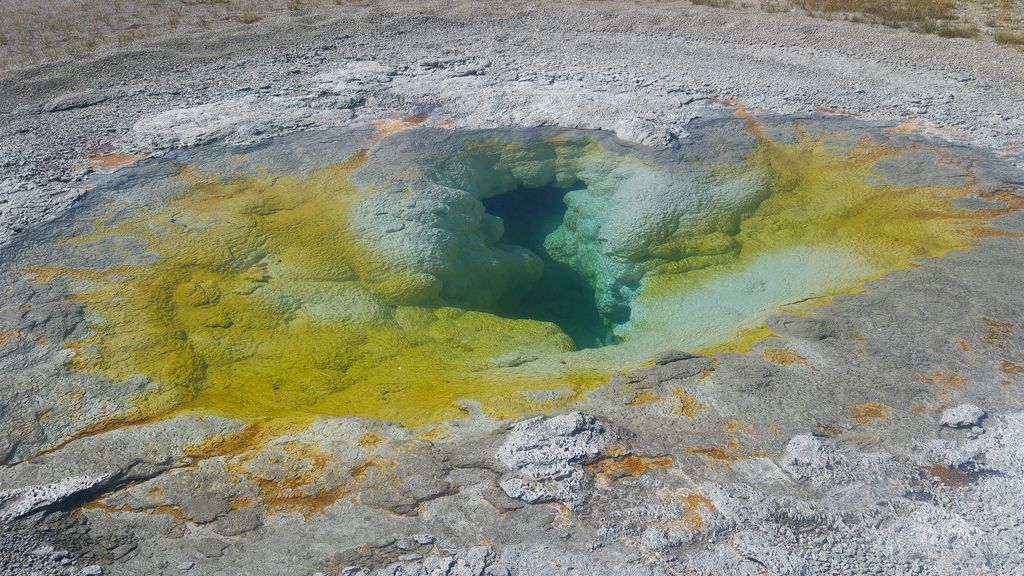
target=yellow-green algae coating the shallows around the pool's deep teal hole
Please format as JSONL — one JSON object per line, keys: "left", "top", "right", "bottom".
{"left": 33, "top": 121, "right": 1010, "bottom": 426}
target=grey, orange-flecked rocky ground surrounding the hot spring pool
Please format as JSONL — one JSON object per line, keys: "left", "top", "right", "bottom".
{"left": 0, "top": 1, "right": 1024, "bottom": 576}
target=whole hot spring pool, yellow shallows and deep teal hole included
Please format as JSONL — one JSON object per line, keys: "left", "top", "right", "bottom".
{"left": 14, "top": 118, "right": 1021, "bottom": 427}
